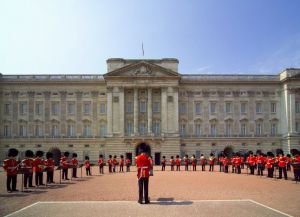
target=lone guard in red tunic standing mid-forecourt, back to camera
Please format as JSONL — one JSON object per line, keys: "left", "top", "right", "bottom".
{"left": 136, "top": 143, "right": 151, "bottom": 204}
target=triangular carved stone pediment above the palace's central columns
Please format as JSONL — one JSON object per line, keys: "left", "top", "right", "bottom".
{"left": 104, "top": 61, "right": 179, "bottom": 77}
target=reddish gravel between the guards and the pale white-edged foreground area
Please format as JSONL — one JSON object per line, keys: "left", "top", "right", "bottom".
{"left": 0, "top": 167, "right": 300, "bottom": 217}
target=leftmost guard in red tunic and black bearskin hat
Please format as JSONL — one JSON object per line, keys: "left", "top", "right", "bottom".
{"left": 3, "top": 148, "right": 19, "bottom": 193}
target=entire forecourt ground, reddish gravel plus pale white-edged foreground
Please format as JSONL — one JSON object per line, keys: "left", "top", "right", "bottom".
{"left": 0, "top": 167, "right": 300, "bottom": 217}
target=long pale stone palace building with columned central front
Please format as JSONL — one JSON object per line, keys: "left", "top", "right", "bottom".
{"left": 0, "top": 58, "right": 300, "bottom": 164}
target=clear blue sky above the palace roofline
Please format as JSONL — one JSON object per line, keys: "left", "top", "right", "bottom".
{"left": 0, "top": 0, "right": 300, "bottom": 74}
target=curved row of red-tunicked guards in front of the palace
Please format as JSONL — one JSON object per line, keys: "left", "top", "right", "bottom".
{"left": 3, "top": 148, "right": 300, "bottom": 192}
